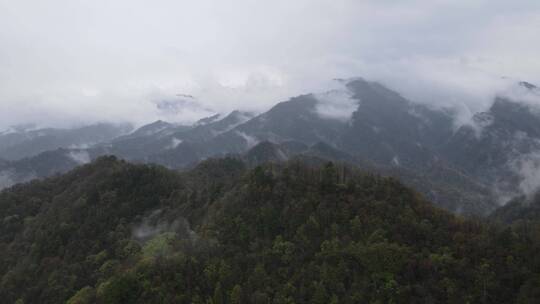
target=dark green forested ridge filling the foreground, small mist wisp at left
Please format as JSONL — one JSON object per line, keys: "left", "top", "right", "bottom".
{"left": 0, "top": 157, "right": 540, "bottom": 304}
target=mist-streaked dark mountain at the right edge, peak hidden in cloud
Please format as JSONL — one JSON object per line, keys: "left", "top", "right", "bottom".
{"left": 439, "top": 83, "right": 540, "bottom": 195}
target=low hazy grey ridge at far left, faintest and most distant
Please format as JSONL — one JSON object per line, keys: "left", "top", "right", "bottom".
{"left": 0, "top": 123, "right": 131, "bottom": 160}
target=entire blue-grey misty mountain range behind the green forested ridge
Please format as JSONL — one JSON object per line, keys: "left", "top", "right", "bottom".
{"left": 0, "top": 78, "right": 540, "bottom": 215}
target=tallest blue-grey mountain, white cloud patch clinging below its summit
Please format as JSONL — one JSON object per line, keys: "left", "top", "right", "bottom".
{"left": 198, "top": 79, "right": 496, "bottom": 214}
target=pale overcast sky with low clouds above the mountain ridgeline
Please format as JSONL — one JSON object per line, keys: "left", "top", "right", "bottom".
{"left": 0, "top": 0, "right": 540, "bottom": 127}
